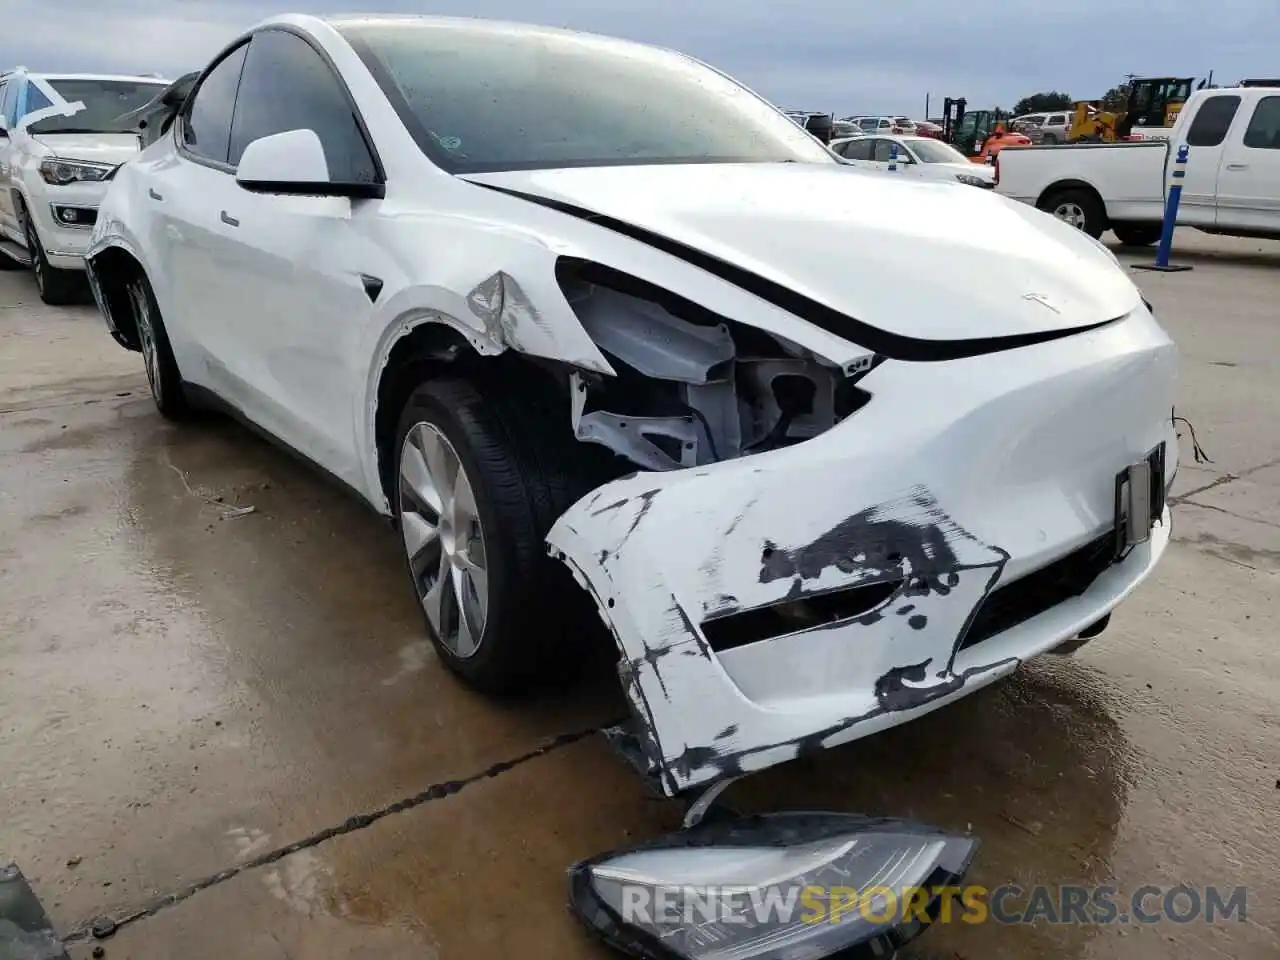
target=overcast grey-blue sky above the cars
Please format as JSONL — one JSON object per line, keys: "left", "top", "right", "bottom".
{"left": 10, "top": 0, "right": 1280, "bottom": 116}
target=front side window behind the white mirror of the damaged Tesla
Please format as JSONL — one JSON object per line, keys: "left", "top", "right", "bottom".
{"left": 229, "top": 29, "right": 379, "bottom": 183}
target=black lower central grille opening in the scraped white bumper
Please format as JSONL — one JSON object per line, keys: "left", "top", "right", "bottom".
{"left": 960, "top": 534, "right": 1115, "bottom": 650}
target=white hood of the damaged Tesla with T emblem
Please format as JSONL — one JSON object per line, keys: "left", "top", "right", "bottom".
{"left": 466, "top": 164, "right": 1140, "bottom": 340}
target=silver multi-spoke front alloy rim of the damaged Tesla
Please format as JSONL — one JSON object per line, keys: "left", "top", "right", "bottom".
{"left": 399, "top": 422, "right": 489, "bottom": 659}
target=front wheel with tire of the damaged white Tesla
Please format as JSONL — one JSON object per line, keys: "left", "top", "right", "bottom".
{"left": 392, "top": 378, "right": 604, "bottom": 694}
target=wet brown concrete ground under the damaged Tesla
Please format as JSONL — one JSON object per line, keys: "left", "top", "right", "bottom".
{"left": 0, "top": 237, "right": 1280, "bottom": 960}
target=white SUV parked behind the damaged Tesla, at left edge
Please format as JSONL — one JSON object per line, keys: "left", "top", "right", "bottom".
{"left": 0, "top": 67, "right": 168, "bottom": 303}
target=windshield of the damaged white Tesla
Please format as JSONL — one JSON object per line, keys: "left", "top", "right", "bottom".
{"left": 334, "top": 18, "right": 838, "bottom": 173}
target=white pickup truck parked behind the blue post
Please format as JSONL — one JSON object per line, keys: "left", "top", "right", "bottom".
{"left": 996, "top": 87, "right": 1280, "bottom": 246}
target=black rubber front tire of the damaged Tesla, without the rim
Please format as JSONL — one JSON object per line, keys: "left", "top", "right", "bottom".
{"left": 390, "top": 376, "right": 602, "bottom": 695}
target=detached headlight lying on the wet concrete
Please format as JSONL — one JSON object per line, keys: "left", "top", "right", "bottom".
{"left": 570, "top": 813, "right": 978, "bottom": 960}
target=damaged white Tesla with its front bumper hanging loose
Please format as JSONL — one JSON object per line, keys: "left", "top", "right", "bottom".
{"left": 87, "top": 15, "right": 1178, "bottom": 814}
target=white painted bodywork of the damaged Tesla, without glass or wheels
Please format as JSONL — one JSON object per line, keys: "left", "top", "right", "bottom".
{"left": 82, "top": 15, "right": 1176, "bottom": 792}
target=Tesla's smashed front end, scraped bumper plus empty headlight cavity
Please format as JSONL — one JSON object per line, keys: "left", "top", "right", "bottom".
{"left": 532, "top": 252, "right": 1176, "bottom": 796}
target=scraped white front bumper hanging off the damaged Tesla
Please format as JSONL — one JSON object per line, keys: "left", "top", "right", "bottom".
{"left": 548, "top": 308, "right": 1178, "bottom": 795}
